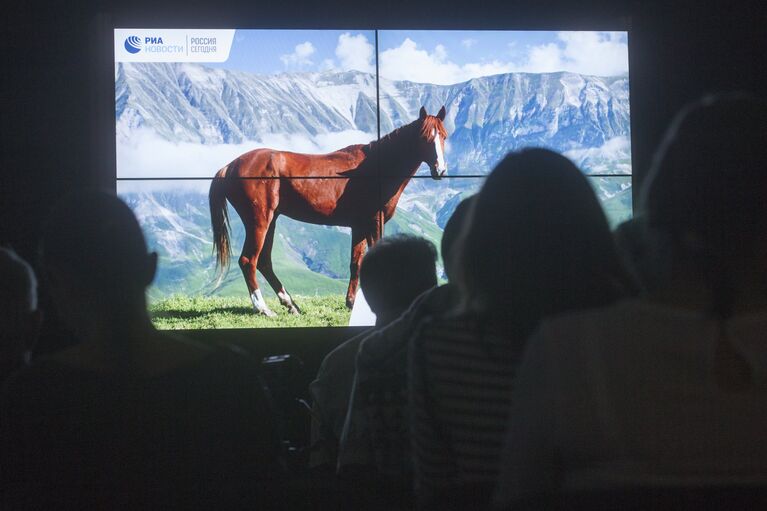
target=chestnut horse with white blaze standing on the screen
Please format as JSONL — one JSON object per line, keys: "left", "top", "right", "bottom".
{"left": 209, "top": 106, "right": 447, "bottom": 316}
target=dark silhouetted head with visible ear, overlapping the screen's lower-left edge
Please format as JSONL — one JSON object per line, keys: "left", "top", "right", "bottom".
{"left": 42, "top": 191, "right": 157, "bottom": 332}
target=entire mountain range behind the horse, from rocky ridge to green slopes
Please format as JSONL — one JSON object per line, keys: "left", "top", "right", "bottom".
{"left": 115, "top": 63, "right": 631, "bottom": 299}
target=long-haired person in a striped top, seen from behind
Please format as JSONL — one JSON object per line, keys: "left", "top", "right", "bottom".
{"left": 409, "top": 149, "right": 629, "bottom": 509}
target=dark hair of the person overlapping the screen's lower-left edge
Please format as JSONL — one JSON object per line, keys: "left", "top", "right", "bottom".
{"left": 41, "top": 191, "right": 154, "bottom": 299}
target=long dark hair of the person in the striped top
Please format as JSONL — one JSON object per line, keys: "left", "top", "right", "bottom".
{"left": 456, "top": 149, "right": 633, "bottom": 339}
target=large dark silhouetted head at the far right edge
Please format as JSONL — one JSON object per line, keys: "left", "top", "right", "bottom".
{"left": 641, "top": 93, "right": 767, "bottom": 274}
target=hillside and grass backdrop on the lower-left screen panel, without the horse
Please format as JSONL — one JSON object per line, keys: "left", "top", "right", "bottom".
{"left": 117, "top": 180, "right": 351, "bottom": 329}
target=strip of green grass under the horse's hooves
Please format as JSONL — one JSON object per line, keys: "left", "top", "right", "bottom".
{"left": 150, "top": 295, "right": 351, "bottom": 330}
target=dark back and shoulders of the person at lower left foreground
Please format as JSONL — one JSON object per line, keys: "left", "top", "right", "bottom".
{"left": 0, "top": 342, "right": 280, "bottom": 506}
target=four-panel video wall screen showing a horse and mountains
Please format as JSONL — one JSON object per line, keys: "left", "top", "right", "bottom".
{"left": 114, "top": 28, "right": 632, "bottom": 329}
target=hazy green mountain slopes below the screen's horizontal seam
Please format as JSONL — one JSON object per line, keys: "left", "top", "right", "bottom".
{"left": 140, "top": 175, "right": 632, "bottom": 312}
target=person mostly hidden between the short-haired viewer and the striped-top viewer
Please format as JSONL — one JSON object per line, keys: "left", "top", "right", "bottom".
{"left": 338, "top": 196, "right": 474, "bottom": 480}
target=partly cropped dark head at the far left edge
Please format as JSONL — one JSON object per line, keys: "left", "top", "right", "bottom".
{"left": 0, "top": 247, "right": 41, "bottom": 384}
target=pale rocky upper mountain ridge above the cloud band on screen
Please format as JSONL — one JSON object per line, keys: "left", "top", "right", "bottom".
{"left": 115, "top": 63, "right": 630, "bottom": 174}
